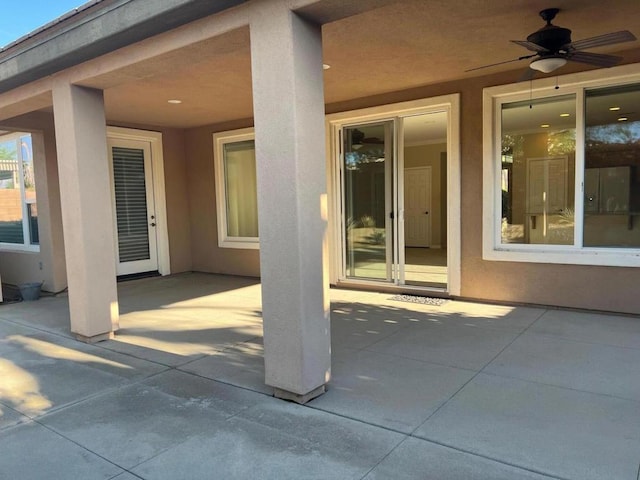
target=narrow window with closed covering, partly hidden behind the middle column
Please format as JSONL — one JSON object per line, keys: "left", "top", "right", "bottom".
{"left": 213, "top": 129, "right": 259, "bottom": 248}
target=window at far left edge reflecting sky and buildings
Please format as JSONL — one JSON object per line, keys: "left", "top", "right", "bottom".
{"left": 0, "top": 133, "right": 39, "bottom": 251}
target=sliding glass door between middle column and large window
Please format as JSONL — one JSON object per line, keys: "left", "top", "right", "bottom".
{"left": 340, "top": 112, "right": 448, "bottom": 289}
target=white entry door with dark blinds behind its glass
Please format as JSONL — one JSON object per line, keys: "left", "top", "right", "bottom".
{"left": 108, "top": 138, "right": 158, "bottom": 275}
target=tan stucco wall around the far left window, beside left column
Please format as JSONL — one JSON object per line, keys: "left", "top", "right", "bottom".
{"left": 0, "top": 112, "right": 67, "bottom": 292}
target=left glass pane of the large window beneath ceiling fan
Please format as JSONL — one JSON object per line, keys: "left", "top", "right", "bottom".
{"left": 501, "top": 95, "right": 576, "bottom": 245}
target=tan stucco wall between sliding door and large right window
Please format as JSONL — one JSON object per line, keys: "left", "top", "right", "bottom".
{"left": 327, "top": 69, "right": 640, "bottom": 314}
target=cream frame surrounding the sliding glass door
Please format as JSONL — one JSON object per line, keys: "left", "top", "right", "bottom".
{"left": 326, "top": 94, "right": 461, "bottom": 296}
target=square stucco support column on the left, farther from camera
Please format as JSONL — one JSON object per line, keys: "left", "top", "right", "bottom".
{"left": 53, "top": 83, "right": 118, "bottom": 342}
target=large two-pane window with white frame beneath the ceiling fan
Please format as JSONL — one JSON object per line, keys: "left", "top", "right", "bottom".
{"left": 483, "top": 69, "right": 640, "bottom": 266}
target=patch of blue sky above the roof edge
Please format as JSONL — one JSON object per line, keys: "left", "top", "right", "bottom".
{"left": 0, "top": 0, "right": 88, "bottom": 46}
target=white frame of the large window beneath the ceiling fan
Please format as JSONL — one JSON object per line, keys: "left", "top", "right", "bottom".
{"left": 482, "top": 64, "right": 640, "bottom": 267}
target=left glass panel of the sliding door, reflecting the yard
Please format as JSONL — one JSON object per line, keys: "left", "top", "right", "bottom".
{"left": 342, "top": 120, "right": 393, "bottom": 282}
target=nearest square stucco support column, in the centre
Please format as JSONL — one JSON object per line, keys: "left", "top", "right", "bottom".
{"left": 250, "top": 2, "right": 331, "bottom": 403}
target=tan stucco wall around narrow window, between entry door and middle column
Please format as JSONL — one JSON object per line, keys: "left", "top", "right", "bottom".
{"left": 185, "top": 121, "right": 260, "bottom": 277}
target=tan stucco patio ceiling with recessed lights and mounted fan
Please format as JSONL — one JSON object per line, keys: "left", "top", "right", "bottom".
{"left": 72, "top": 0, "right": 640, "bottom": 128}
